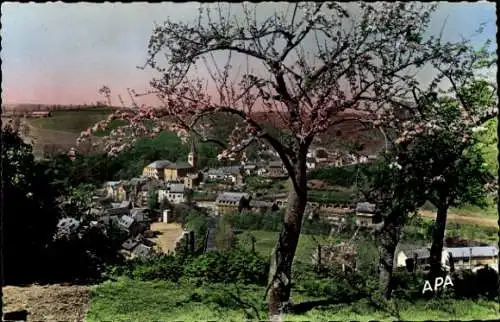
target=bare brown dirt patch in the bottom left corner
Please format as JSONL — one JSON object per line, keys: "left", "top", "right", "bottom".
{"left": 3, "top": 284, "right": 90, "bottom": 322}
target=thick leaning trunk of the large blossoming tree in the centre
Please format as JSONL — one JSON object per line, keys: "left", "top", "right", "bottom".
{"left": 268, "top": 166, "right": 307, "bottom": 320}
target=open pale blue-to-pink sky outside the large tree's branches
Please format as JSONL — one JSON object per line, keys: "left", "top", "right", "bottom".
{"left": 0, "top": 2, "right": 496, "bottom": 105}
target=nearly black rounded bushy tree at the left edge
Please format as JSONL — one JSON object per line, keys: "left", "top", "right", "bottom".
{"left": 0, "top": 130, "right": 61, "bottom": 284}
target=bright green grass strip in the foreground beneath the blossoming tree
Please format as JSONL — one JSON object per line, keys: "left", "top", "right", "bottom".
{"left": 87, "top": 278, "right": 499, "bottom": 322}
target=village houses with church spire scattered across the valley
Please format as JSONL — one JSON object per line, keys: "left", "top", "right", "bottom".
{"left": 67, "top": 143, "right": 498, "bottom": 271}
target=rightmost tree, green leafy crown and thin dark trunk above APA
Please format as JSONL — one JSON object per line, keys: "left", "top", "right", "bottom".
{"left": 427, "top": 80, "right": 498, "bottom": 275}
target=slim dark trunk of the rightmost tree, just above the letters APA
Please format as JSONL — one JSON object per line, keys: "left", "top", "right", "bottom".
{"left": 430, "top": 198, "right": 448, "bottom": 277}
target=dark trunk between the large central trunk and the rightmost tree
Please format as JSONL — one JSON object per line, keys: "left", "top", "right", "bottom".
{"left": 379, "top": 213, "right": 404, "bottom": 299}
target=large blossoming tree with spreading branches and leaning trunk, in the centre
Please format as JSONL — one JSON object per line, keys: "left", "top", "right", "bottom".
{"left": 84, "top": 3, "right": 472, "bottom": 317}
